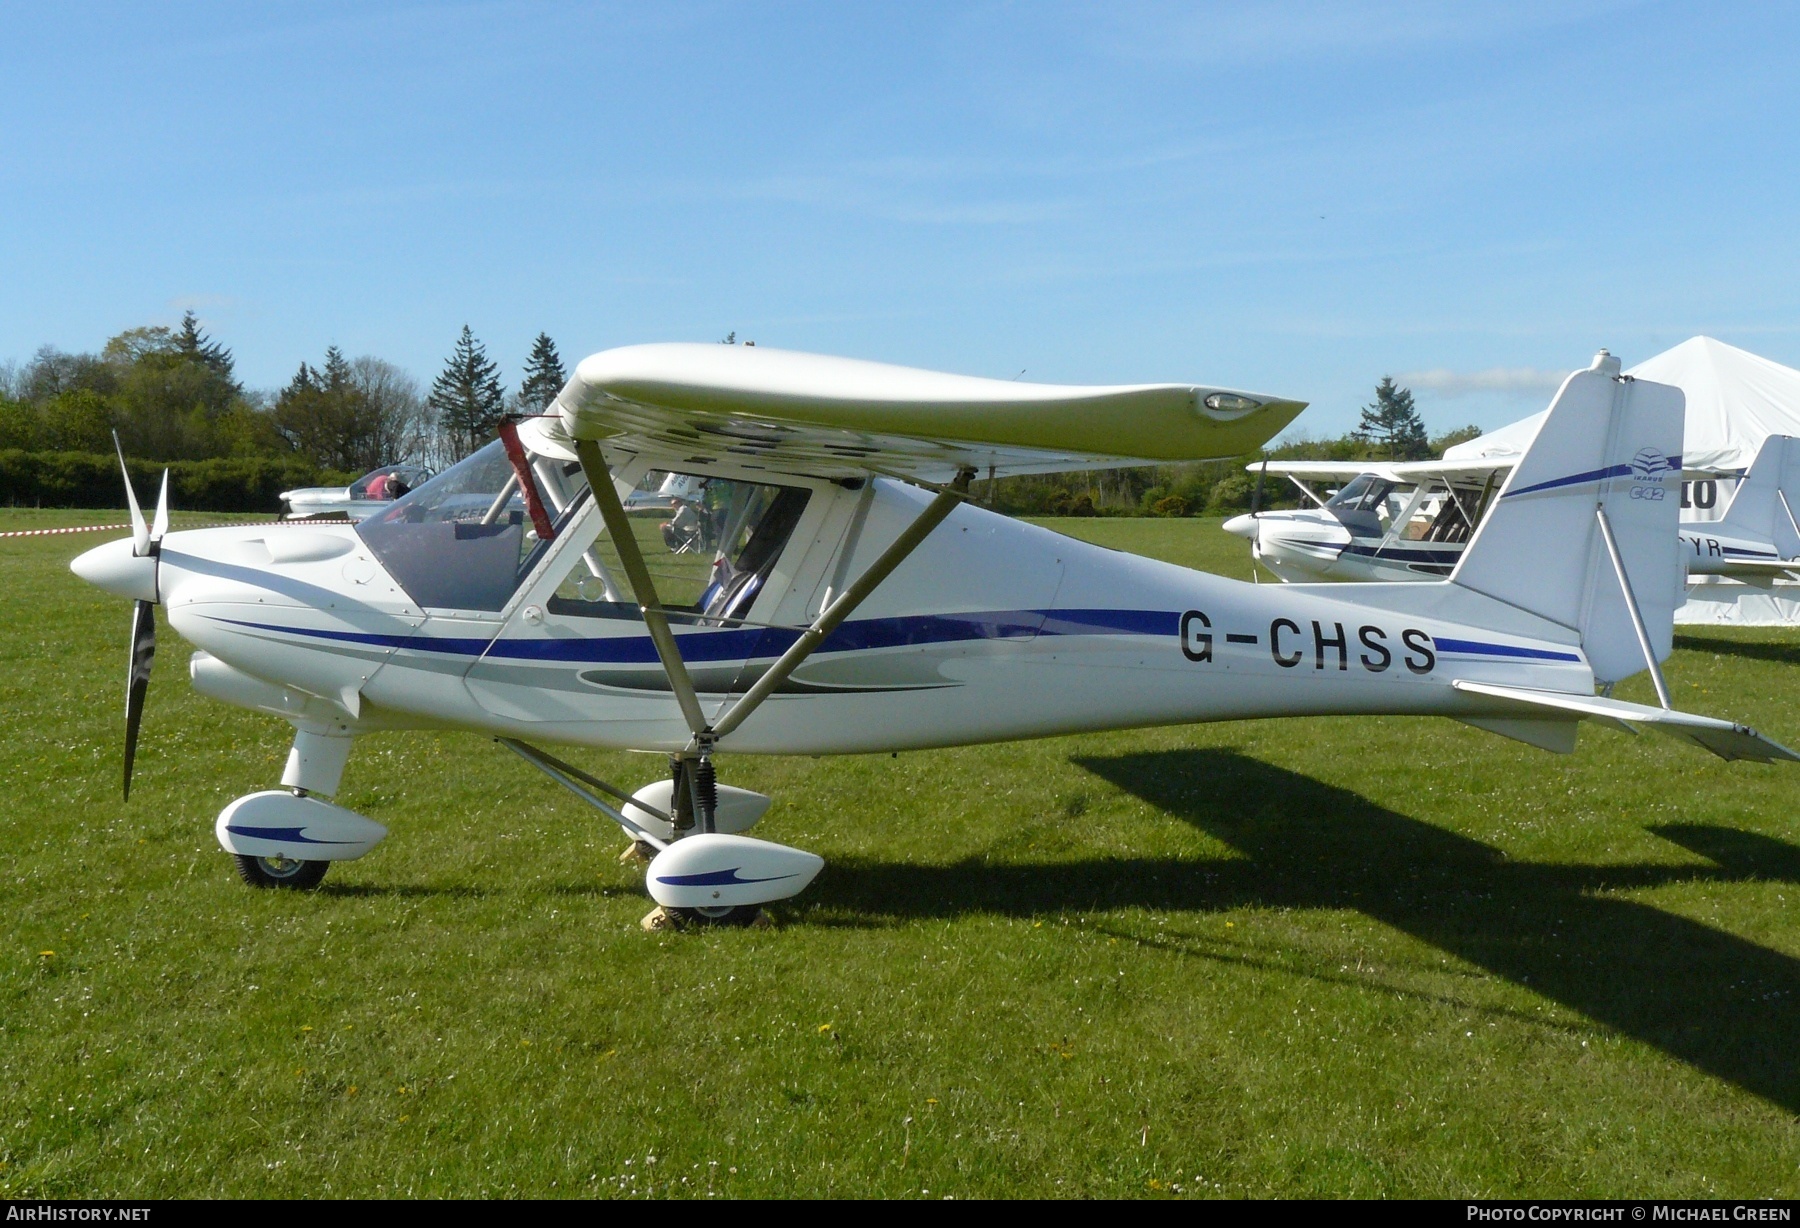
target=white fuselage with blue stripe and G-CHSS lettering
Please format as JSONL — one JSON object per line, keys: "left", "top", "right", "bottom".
{"left": 136, "top": 465, "right": 1593, "bottom": 754}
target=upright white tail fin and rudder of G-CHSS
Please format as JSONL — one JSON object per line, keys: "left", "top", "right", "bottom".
{"left": 1451, "top": 351, "right": 1687, "bottom": 682}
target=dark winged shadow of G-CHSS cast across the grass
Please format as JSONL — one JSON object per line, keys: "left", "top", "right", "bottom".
{"left": 815, "top": 751, "right": 1800, "bottom": 1113}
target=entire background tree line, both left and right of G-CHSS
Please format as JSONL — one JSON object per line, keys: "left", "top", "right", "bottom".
{"left": 0, "top": 312, "right": 1480, "bottom": 515}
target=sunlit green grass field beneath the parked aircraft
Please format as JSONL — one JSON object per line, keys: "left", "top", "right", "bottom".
{"left": 0, "top": 511, "right": 1800, "bottom": 1197}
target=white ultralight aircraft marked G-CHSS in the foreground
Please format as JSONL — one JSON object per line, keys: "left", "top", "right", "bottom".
{"left": 72, "top": 346, "right": 1796, "bottom": 924}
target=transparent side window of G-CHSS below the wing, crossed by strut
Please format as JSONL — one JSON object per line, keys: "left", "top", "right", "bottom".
{"left": 549, "top": 470, "right": 808, "bottom": 621}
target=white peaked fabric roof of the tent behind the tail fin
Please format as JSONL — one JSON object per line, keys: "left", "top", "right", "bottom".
{"left": 1444, "top": 337, "right": 1800, "bottom": 474}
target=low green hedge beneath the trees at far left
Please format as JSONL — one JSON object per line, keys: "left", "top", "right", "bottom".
{"left": 0, "top": 448, "right": 356, "bottom": 511}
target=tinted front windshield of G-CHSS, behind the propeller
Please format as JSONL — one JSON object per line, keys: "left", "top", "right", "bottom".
{"left": 345, "top": 439, "right": 587, "bottom": 610}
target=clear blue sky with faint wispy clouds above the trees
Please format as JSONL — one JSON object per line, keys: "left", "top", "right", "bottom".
{"left": 0, "top": 0, "right": 1800, "bottom": 434}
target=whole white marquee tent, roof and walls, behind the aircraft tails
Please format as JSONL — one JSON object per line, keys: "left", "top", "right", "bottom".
{"left": 1444, "top": 337, "right": 1800, "bottom": 627}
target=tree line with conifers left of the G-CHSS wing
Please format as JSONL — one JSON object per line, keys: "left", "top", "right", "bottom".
{"left": 0, "top": 312, "right": 567, "bottom": 474}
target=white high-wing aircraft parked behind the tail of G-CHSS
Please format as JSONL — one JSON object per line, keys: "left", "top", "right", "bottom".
{"left": 1224, "top": 351, "right": 1800, "bottom": 582}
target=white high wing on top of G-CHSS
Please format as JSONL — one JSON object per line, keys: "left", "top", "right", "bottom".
{"left": 535, "top": 344, "right": 1305, "bottom": 481}
